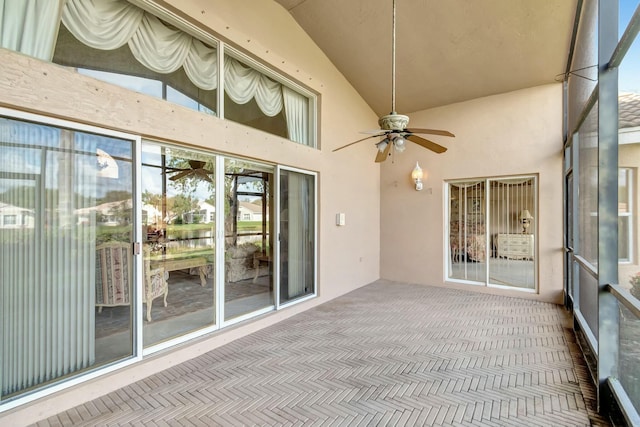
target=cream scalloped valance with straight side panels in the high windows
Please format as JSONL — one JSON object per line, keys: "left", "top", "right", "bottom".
{"left": 0, "top": 0, "right": 308, "bottom": 144}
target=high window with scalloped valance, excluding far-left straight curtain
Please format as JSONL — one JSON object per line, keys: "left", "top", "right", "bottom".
{"left": 48, "top": 0, "right": 315, "bottom": 147}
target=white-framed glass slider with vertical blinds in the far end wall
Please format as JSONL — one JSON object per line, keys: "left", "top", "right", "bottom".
{"left": 447, "top": 176, "right": 537, "bottom": 291}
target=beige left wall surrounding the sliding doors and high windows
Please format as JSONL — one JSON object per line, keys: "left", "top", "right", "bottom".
{"left": 0, "top": 0, "right": 380, "bottom": 425}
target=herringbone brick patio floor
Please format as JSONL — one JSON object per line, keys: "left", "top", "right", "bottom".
{"left": 32, "top": 281, "right": 605, "bottom": 427}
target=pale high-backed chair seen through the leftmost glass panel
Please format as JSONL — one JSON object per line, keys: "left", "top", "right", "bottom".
{"left": 96, "top": 242, "right": 133, "bottom": 313}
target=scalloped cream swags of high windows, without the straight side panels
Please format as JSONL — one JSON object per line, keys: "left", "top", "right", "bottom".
{"left": 62, "top": 0, "right": 300, "bottom": 127}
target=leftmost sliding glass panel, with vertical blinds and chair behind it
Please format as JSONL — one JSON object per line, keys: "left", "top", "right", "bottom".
{"left": 0, "top": 111, "right": 135, "bottom": 400}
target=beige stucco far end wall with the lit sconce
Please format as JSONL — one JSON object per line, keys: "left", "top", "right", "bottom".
{"left": 380, "top": 84, "right": 563, "bottom": 303}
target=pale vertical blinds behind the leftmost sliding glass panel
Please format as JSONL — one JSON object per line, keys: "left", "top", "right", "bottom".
{"left": 0, "top": 118, "right": 96, "bottom": 397}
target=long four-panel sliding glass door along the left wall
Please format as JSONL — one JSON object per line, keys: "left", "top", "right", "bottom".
{"left": 0, "top": 112, "right": 317, "bottom": 400}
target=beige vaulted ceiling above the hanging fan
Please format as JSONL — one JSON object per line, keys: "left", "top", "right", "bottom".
{"left": 276, "top": 0, "right": 577, "bottom": 115}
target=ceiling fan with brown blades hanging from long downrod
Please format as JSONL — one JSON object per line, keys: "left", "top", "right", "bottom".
{"left": 333, "top": 0, "right": 455, "bottom": 163}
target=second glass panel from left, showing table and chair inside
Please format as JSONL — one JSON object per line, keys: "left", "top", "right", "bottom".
{"left": 141, "top": 141, "right": 216, "bottom": 346}
